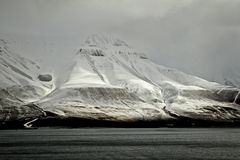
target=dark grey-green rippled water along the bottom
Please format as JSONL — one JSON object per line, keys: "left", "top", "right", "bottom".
{"left": 0, "top": 128, "right": 240, "bottom": 160}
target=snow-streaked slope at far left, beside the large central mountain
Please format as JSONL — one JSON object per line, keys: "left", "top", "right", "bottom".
{"left": 0, "top": 39, "right": 54, "bottom": 121}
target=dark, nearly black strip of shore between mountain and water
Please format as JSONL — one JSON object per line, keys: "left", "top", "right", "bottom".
{"left": 0, "top": 118, "right": 240, "bottom": 130}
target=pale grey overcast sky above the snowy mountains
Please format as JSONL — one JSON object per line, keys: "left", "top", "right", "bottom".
{"left": 0, "top": 0, "right": 240, "bottom": 80}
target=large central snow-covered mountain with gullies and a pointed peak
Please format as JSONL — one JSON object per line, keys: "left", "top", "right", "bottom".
{"left": 0, "top": 35, "right": 240, "bottom": 127}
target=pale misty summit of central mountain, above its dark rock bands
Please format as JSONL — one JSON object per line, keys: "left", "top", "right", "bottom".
{"left": 85, "top": 34, "right": 129, "bottom": 47}
